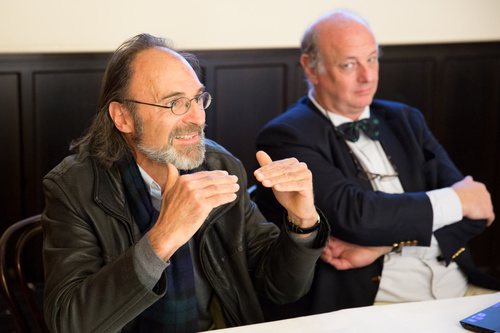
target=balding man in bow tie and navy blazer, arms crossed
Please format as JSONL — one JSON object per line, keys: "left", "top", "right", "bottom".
{"left": 256, "top": 12, "right": 500, "bottom": 319}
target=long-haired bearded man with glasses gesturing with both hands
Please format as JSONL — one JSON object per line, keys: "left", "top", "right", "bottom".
{"left": 42, "top": 34, "right": 382, "bottom": 333}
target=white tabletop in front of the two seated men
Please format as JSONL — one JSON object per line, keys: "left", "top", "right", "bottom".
{"left": 214, "top": 292, "right": 500, "bottom": 333}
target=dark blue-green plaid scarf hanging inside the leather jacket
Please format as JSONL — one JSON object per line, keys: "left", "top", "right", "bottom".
{"left": 117, "top": 156, "right": 198, "bottom": 333}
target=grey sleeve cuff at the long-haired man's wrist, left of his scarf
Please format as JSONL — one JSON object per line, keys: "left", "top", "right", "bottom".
{"left": 134, "top": 234, "right": 170, "bottom": 290}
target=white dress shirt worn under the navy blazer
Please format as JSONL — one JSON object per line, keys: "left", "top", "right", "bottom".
{"left": 309, "top": 92, "right": 467, "bottom": 302}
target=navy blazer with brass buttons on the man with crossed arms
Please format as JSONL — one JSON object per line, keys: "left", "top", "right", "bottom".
{"left": 255, "top": 97, "right": 500, "bottom": 319}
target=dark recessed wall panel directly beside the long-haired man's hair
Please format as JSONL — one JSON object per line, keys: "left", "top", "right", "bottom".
{"left": 33, "top": 70, "right": 104, "bottom": 213}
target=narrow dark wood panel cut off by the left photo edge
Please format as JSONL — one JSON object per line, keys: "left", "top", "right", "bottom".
{"left": 0, "top": 73, "right": 22, "bottom": 232}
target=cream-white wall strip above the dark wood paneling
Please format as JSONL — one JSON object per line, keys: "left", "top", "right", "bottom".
{"left": 0, "top": 0, "right": 500, "bottom": 53}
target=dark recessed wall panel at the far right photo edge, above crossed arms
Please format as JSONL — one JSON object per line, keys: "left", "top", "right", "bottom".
{"left": 439, "top": 58, "right": 500, "bottom": 185}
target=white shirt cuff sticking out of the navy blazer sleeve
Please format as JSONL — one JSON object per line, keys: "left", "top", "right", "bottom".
{"left": 426, "top": 187, "right": 463, "bottom": 231}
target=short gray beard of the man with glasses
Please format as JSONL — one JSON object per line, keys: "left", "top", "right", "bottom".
{"left": 133, "top": 122, "right": 205, "bottom": 170}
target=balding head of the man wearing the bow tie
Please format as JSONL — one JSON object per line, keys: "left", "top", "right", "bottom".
{"left": 300, "top": 11, "right": 379, "bottom": 119}
